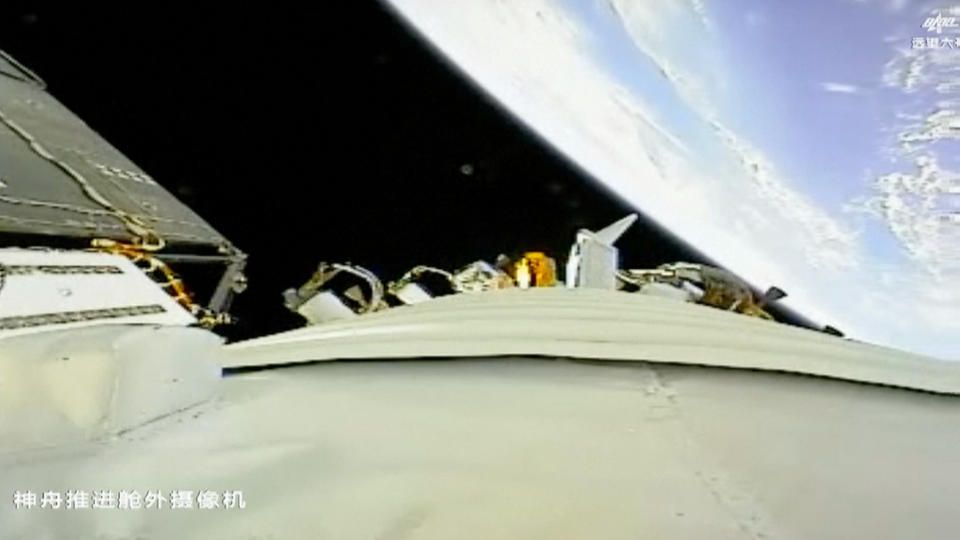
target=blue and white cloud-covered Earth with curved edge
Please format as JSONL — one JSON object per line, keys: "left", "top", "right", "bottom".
{"left": 382, "top": 0, "right": 960, "bottom": 359}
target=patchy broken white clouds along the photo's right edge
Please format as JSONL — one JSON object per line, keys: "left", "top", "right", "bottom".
{"left": 836, "top": 30, "right": 960, "bottom": 359}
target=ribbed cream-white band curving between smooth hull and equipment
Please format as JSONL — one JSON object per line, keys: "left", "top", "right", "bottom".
{"left": 224, "top": 288, "right": 960, "bottom": 394}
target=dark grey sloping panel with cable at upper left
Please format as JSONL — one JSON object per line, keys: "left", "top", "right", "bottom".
{"left": 0, "top": 59, "right": 227, "bottom": 249}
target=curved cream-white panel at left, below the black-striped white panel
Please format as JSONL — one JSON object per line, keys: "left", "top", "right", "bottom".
{"left": 0, "top": 325, "right": 222, "bottom": 454}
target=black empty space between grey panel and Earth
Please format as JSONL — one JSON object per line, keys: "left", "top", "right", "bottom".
{"left": 0, "top": 4, "right": 808, "bottom": 338}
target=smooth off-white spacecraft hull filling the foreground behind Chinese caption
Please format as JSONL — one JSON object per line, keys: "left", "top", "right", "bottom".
{"left": 0, "top": 358, "right": 960, "bottom": 540}
